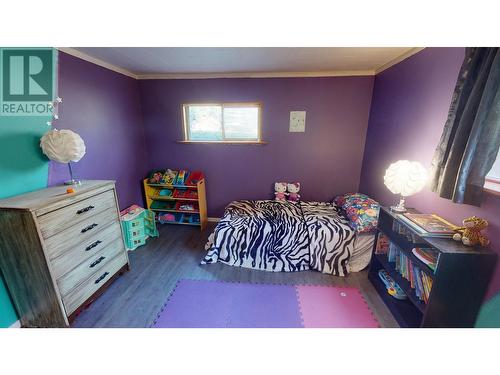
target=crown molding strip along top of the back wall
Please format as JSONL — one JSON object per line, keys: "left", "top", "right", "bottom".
{"left": 137, "top": 70, "right": 375, "bottom": 80}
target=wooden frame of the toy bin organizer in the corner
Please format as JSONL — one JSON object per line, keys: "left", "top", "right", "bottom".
{"left": 143, "top": 178, "right": 207, "bottom": 230}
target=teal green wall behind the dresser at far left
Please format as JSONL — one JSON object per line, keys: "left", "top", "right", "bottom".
{"left": 0, "top": 47, "right": 56, "bottom": 327}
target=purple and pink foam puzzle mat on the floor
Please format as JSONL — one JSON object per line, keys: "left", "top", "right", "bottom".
{"left": 151, "top": 279, "right": 380, "bottom": 328}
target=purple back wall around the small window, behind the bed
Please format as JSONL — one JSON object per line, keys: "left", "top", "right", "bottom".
{"left": 139, "top": 77, "right": 373, "bottom": 216}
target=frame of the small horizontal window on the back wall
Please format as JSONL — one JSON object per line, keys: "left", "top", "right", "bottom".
{"left": 181, "top": 102, "right": 266, "bottom": 144}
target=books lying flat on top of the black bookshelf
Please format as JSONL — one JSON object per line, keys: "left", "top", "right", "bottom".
{"left": 398, "top": 213, "right": 455, "bottom": 238}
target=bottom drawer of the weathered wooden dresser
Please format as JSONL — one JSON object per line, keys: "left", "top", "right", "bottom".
{"left": 62, "top": 253, "right": 127, "bottom": 315}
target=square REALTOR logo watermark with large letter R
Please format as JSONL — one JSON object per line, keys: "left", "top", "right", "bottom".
{"left": 0, "top": 48, "right": 55, "bottom": 116}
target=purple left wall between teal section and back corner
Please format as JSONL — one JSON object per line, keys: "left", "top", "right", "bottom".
{"left": 49, "top": 52, "right": 148, "bottom": 208}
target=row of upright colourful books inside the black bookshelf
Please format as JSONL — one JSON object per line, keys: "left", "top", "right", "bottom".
{"left": 387, "top": 243, "right": 432, "bottom": 303}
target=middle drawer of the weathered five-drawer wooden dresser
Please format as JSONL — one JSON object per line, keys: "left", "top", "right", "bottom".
{"left": 50, "top": 221, "right": 125, "bottom": 279}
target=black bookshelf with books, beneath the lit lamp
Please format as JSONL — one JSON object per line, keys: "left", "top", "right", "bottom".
{"left": 368, "top": 207, "right": 497, "bottom": 327}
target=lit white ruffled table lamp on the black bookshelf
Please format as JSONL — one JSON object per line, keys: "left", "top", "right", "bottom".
{"left": 384, "top": 160, "right": 427, "bottom": 212}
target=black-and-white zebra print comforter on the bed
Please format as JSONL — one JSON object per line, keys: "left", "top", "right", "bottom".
{"left": 202, "top": 200, "right": 355, "bottom": 276}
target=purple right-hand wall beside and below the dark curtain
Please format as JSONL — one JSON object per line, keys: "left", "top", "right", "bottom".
{"left": 360, "top": 48, "right": 500, "bottom": 298}
